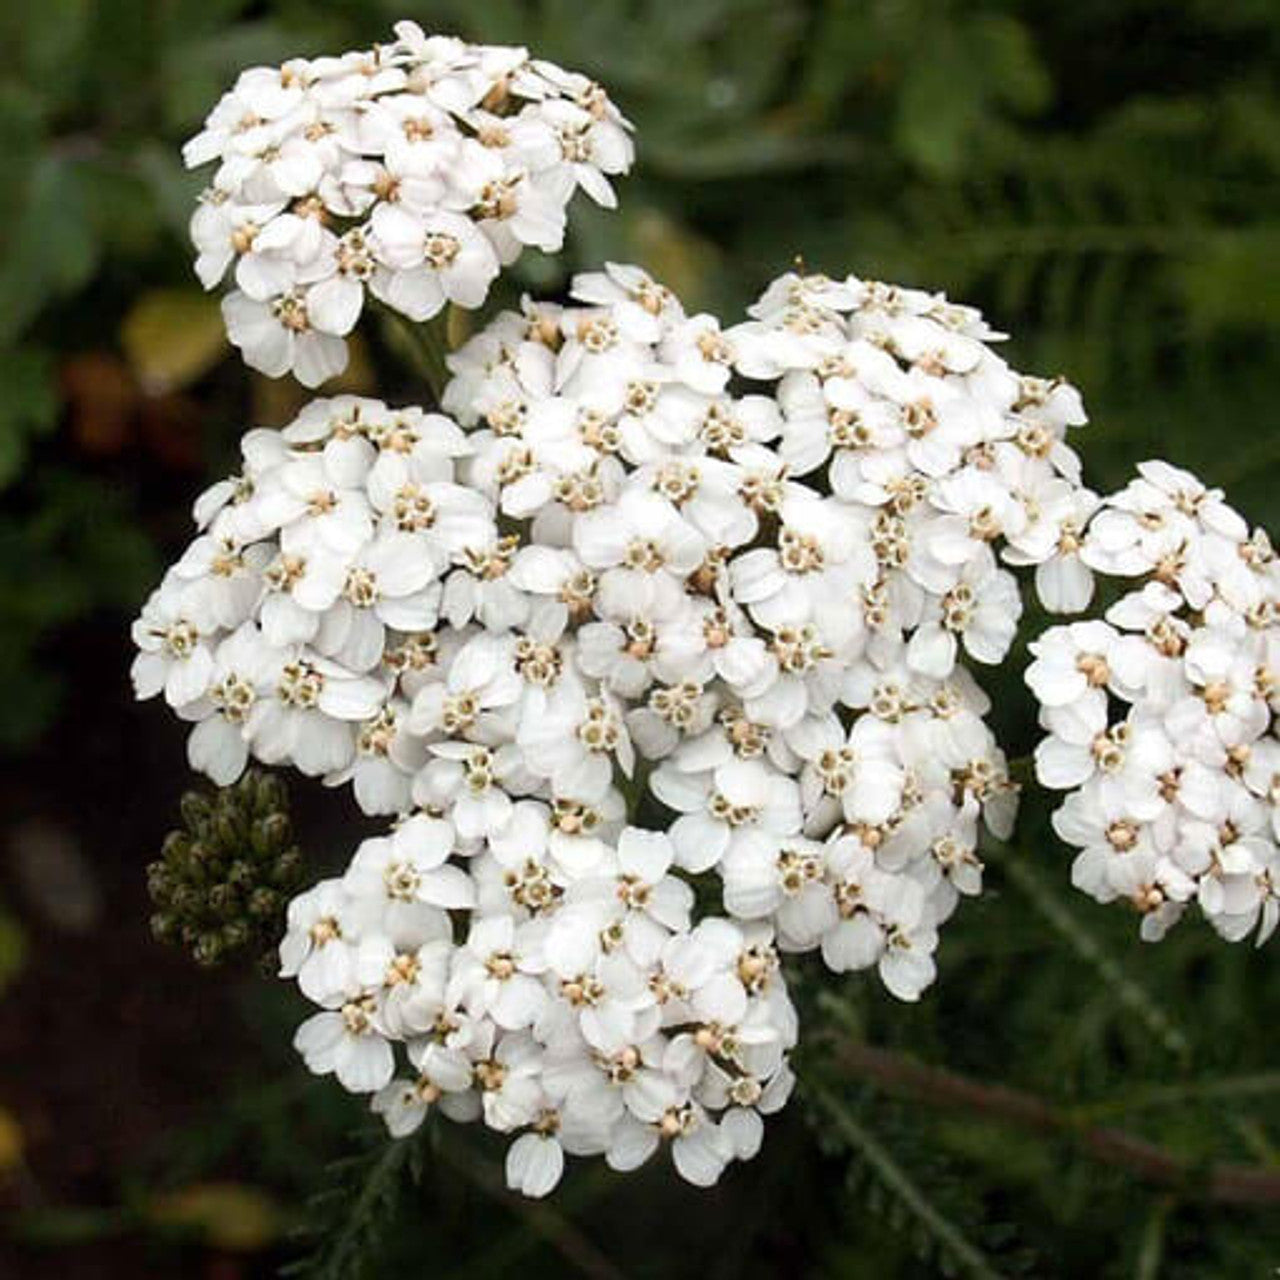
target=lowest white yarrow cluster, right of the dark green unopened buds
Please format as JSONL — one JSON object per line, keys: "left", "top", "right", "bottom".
{"left": 280, "top": 800, "right": 796, "bottom": 1196}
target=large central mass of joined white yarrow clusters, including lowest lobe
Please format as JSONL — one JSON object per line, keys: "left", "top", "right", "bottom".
{"left": 134, "top": 257, "right": 1091, "bottom": 1192}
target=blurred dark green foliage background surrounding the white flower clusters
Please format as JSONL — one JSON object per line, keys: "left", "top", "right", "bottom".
{"left": 0, "top": 0, "right": 1280, "bottom": 1280}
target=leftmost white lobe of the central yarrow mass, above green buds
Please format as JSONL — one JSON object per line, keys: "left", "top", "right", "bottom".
{"left": 133, "top": 397, "right": 481, "bottom": 814}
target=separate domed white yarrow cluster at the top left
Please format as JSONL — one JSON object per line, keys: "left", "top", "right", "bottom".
{"left": 183, "top": 22, "right": 634, "bottom": 387}
